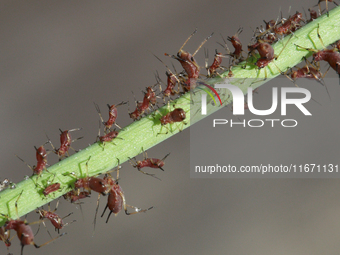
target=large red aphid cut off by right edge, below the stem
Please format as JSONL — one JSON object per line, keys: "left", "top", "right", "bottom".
{"left": 295, "top": 26, "right": 340, "bottom": 78}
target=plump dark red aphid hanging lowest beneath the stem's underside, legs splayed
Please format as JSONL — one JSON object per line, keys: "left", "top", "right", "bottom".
{"left": 101, "top": 163, "right": 153, "bottom": 223}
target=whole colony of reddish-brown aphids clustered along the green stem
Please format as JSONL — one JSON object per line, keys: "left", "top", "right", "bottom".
{"left": 0, "top": 0, "right": 340, "bottom": 254}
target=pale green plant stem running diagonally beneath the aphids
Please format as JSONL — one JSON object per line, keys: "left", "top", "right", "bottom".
{"left": 0, "top": 7, "right": 340, "bottom": 226}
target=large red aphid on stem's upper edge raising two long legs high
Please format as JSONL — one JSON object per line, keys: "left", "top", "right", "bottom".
{"left": 165, "top": 29, "right": 213, "bottom": 91}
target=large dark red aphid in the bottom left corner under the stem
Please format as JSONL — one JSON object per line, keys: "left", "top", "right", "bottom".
{"left": 1, "top": 191, "right": 66, "bottom": 255}
